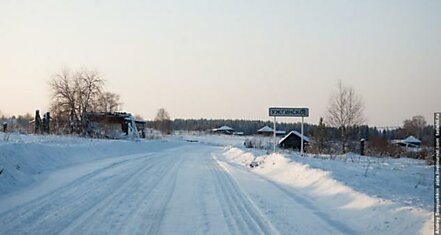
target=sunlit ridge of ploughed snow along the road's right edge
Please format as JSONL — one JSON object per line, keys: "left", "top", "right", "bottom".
{"left": 224, "top": 148, "right": 433, "bottom": 234}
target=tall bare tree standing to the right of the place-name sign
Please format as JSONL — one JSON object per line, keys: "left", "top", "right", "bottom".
{"left": 327, "top": 81, "right": 365, "bottom": 153}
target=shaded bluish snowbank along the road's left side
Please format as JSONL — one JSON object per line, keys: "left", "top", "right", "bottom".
{"left": 0, "top": 133, "right": 179, "bottom": 196}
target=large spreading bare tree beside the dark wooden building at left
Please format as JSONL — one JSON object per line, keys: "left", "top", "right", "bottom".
{"left": 49, "top": 69, "right": 104, "bottom": 132}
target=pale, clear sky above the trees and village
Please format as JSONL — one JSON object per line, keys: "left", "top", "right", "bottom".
{"left": 0, "top": 0, "right": 441, "bottom": 126}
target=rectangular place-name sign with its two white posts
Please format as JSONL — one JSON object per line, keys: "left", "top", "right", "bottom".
{"left": 269, "top": 108, "right": 309, "bottom": 156}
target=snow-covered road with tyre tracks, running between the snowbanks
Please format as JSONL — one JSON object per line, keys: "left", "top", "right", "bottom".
{"left": 0, "top": 139, "right": 434, "bottom": 234}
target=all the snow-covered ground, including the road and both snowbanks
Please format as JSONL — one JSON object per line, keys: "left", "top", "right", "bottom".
{"left": 0, "top": 133, "right": 433, "bottom": 234}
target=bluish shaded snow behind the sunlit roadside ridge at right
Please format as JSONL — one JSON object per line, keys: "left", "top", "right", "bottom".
{"left": 287, "top": 154, "right": 434, "bottom": 210}
